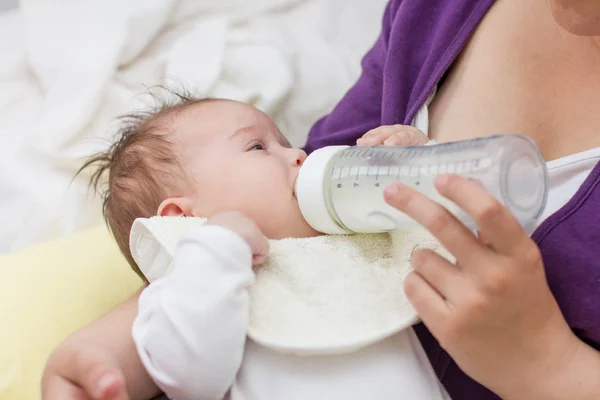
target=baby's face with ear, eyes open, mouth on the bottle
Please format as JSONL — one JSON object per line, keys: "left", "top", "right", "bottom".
{"left": 159, "top": 100, "right": 317, "bottom": 239}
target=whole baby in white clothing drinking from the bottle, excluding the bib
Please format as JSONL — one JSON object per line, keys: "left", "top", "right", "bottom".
{"left": 85, "top": 91, "right": 448, "bottom": 400}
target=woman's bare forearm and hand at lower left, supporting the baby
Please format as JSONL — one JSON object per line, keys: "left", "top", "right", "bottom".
{"left": 42, "top": 292, "right": 160, "bottom": 400}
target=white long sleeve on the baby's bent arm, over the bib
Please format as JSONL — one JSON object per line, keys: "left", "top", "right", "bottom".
{"left": 132, "top": 225, "right": 254, "bottom": 400}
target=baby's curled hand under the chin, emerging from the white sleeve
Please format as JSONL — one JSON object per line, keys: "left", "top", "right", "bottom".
{"left": 206, "top": 212, "right": 269, "bottom": 265}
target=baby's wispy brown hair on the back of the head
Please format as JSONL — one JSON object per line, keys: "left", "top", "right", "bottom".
{"left": 77, "top": 87, "right": 212, "bottom": 280}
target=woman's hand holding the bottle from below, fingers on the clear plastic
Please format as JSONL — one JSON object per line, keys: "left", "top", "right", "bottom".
{"left": 385, "top": 175, "right": 583, "bottom": 399}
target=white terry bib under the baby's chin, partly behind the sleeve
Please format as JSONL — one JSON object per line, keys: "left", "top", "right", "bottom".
{"left": 130, "top": 217, "right": 451, "bottom": 355}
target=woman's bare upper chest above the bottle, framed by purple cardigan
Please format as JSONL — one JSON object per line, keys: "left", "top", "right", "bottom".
{"left": 429, "top": 0, "right": 600, "bottom": 159}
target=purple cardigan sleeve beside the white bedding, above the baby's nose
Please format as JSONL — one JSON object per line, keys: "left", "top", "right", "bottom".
{"left": 304, "top": 0, "right": 402, "bottom": 153}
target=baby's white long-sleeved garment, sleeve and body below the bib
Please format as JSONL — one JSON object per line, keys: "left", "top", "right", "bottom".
{"left": 133, "top": 226, "right": 448, "bottom": 400}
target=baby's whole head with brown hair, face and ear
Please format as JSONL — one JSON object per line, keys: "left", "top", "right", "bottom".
{"left": 82, "top": 90, "right": 317, "bottom": 274}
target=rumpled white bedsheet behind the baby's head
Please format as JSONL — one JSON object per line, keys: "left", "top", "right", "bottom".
{"left": 0, "top": 0, "right": 387, "bottom": 252}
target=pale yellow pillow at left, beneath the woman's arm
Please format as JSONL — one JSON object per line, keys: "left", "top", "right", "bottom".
{"left": 0, "top": 227, "right": 142, "bottom": 400}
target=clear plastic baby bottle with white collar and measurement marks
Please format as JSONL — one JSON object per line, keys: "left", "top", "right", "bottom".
{"left": 296, "top": 135, "right": 548, "bottom": 234}
